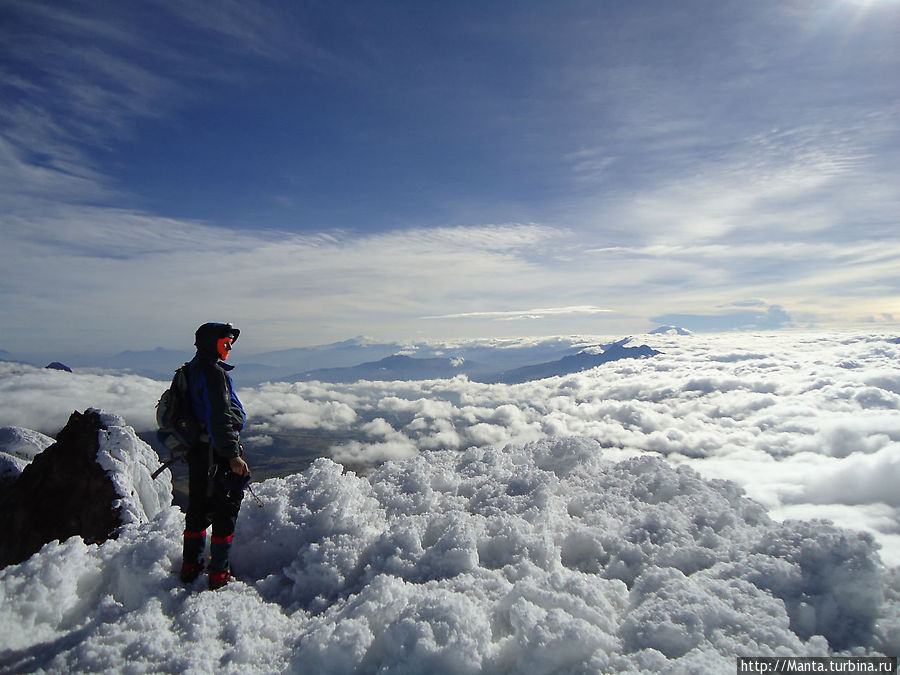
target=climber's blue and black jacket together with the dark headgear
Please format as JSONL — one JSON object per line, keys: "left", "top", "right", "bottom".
{"left": 188, "top": 323, "right": 247, "bottom": 461}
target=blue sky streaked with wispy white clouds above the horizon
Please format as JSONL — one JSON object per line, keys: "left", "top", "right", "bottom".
{"left": 0, "top": 0, "right": 900, "bottom": 354}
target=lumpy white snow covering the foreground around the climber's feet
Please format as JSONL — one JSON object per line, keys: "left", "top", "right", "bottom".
{"left": 0, "top": 430, "right": 900, "bottom": 673}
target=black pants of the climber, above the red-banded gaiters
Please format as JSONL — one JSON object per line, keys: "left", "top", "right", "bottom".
{"left": 185, "top": 443, "right": 244, "bottom": 537}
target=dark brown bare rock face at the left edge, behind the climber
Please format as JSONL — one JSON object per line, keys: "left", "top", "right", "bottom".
{"left": 0, "top": 410, "right": 122, "bottom": 567}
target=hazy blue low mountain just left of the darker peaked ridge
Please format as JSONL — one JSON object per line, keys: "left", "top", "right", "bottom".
{"left": 298, "top": 354, "right": 479, "bottom": 383}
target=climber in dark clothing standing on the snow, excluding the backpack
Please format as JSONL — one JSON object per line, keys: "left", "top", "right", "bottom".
{"left": 181, "top": 323, "right": 250, "bottom": 589}
